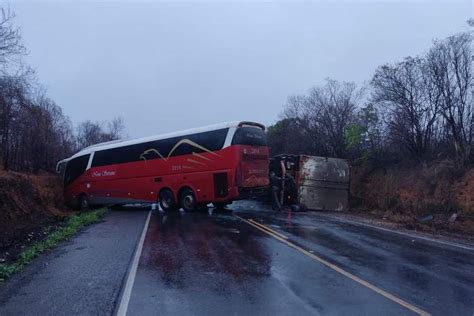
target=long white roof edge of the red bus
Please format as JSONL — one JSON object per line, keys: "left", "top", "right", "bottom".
{"left": 66, "top": 121, "right": 265, "bottom": 163}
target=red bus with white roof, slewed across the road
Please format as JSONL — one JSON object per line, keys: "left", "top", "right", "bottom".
{"left": 57, "top": 122, "right": 269, "bottom": 211}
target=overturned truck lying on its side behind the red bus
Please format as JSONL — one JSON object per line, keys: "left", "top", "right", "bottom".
{"left": 269, "top": 155, "right": 350, "bottom": 211}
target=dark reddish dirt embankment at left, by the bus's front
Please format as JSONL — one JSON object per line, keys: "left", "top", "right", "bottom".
{"left": 0, "top": 170, "right": 68, "bottom": 260}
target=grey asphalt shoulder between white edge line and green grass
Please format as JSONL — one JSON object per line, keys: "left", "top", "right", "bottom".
{"left": 0, "top": 211, "right": 147, "bottom": 315}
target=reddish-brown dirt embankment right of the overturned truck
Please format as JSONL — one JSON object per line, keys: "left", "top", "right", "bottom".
{"left": 351, "top": 161, "right": 474, "bottom": 237}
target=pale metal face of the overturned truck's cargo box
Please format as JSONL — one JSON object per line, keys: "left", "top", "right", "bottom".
{"left": 298, "top": 155, "right": 350, "bottom": 211}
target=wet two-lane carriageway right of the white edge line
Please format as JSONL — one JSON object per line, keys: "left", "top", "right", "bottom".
{"left": 128, "top": 202, "right": 474, "bottom": 315}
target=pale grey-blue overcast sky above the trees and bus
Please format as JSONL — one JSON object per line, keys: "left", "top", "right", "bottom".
{"left": 10, "top": 0, "right": 473, "bottom": 137}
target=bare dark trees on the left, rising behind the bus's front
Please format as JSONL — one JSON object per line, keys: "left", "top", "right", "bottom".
{"left": 0, "top": 8, "right": 124, "bottom": 173}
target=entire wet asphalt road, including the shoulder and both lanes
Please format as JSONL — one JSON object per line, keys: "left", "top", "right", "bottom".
{"left": 0, "top": 202, "right": 474, "bottom": 315}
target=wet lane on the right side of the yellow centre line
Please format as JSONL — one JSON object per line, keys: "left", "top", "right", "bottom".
{"left": 231, "top": 204, "right": 474, "bottom": 315}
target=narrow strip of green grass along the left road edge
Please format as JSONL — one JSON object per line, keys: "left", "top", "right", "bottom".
{"left": 0, "top": 208, "right": 107, "bottom": 282}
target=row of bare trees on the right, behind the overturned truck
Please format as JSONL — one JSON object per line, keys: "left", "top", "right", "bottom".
{"left": 268, "top": 28, "right": 474, "bottom": 165}
